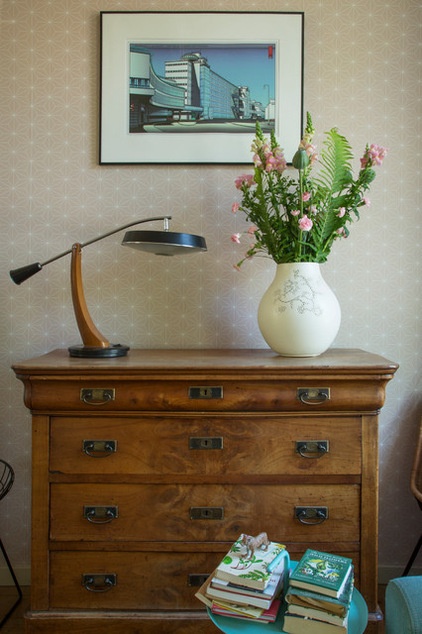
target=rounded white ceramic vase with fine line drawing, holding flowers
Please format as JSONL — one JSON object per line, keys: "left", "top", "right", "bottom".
{"left": 258, "top": 262, "right": 341, "bottom": 357}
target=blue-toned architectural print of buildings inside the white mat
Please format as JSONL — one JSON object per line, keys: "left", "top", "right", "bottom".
{"left": 129, "top": 43, "right": 275, "bottom": 133}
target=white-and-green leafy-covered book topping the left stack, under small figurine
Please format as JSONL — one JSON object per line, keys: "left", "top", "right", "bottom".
{"left": 215, "top": 535, "right": 288, "bottom": 590}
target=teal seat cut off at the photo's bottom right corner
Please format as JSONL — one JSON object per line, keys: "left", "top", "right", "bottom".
{"left": 385, "top": 576, "right": 422, "bottom": 634}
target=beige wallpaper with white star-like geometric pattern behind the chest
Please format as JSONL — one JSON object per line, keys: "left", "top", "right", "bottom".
{"left": 0, "top": 0, "right": 422, "bottom": 579}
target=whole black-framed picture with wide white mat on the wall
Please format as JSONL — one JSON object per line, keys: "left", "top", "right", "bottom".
{"left": 100, "top": 11, "right": 304, "bottom": 164}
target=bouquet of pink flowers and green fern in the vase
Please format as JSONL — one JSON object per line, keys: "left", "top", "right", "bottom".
{"left": 231, "top": 113, "right": 387, "bottom": 267}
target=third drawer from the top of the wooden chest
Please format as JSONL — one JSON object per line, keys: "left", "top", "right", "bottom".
{"left": 50, "top": 484, "right": 360, "bottom": 542}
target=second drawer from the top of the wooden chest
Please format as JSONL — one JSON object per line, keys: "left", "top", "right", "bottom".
{"left": 50, "top": 414, "right": 361, "bottom": 477}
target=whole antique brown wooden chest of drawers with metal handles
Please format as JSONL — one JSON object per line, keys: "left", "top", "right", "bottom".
{"left": 14, "top": 350, "right": 397, "bottom": 634}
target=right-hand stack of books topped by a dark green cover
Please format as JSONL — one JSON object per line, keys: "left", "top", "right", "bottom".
{"left": 283, "top": 549, "right": 354, "bottom": 634}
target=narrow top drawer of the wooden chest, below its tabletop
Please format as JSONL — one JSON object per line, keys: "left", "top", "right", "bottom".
{"left": 27, "top": 374, "right": 383, "bottom": 412}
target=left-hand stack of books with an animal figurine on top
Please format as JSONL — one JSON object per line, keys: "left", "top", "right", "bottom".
{"left": 195, "top": 536, "right": 290, "bottom": 623}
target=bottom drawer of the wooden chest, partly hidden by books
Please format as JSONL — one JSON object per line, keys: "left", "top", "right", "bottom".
{"left": 50, "top": 544, "right": 223, "bottom": 608}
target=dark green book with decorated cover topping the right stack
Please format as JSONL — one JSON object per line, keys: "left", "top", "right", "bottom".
{"left": 290, "top": 548, "right": 353, "bottom": 598}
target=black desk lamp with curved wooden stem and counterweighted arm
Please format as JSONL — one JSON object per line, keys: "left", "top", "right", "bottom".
{"left": 10, "top": 216, "right": 207, "bottom": 358}
